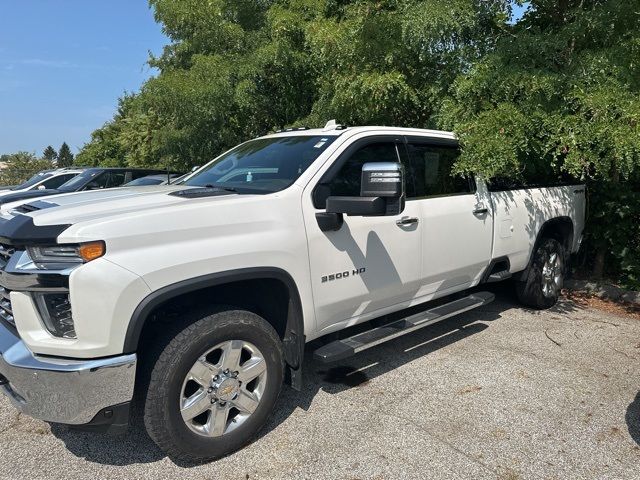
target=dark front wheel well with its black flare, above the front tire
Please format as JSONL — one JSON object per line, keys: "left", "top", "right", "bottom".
{"left": 129, "top": 267, "right": 305, "bottom": 390}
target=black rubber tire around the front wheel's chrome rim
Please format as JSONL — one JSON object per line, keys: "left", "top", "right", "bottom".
{"left": 141, "top": 310, "right": 284, "bottom": 463}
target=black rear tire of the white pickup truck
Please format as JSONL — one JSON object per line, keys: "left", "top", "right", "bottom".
{"left": 516, "top": 238, "right": 566, "bottom": 310}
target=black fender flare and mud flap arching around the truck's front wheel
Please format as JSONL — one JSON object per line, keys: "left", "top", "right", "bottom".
{"left": 123, "top": 267, "right": 305, "bottom": 376}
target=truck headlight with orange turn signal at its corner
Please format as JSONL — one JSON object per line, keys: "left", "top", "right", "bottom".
{"left": 27, "top": 242, "right": 106, "bottom": 270}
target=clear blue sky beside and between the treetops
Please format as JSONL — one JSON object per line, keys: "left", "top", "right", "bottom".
{"left": 0, "top": 0, "right": 523, "bottom": 155}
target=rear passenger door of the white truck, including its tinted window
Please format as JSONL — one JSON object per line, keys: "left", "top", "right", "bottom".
{"left": 406, "top": 137, "right": 493, "bottom": 296}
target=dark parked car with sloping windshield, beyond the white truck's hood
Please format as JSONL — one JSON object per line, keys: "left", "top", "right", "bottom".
{"left": 0, "top": 168, "right": 166, "bottom": 205}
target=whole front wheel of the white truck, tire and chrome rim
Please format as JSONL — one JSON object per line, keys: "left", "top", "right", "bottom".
{"left": 144, "top": 310, "right": 284, "bottom": 462}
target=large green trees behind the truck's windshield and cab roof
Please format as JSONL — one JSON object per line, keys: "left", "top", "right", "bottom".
{"left": 80, "top": 0, "right": 510, "bottom": 168}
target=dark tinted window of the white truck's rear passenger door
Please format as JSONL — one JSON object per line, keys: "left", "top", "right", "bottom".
{"left": 407, "top": 143, "right": 472, "bottom": 198}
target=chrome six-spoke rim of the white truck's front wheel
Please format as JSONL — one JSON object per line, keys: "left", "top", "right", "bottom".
{"left": 180, "top": 340, "right": 267, "bottom": 437}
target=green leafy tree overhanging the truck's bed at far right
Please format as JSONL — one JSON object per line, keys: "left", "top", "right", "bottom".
{"left": 441, "top": 0, "right": 640, "bottom": 285}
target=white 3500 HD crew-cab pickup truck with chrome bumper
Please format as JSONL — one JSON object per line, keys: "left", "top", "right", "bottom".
{"left": 0, "top": 122, "right": 585, "bottom": 460}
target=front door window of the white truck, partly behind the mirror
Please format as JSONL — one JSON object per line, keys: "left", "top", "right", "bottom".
{"left": 329, "top": 142, "right": 398, "bottom": 197}
